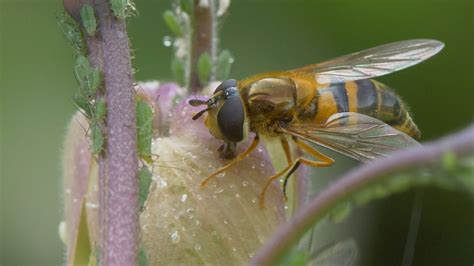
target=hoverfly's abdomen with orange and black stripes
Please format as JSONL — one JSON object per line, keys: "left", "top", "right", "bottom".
{"left": 315, "top": 79, "right": 421, "bottom": 138}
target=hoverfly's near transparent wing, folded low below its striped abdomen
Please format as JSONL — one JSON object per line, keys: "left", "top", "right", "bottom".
{"left": 281, "top": 112, "right": 420, "bottom": 162}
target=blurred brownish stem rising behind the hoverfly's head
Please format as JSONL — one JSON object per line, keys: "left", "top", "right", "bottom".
{"left": 188, "top": 0, "right": 217, "bottom": 93}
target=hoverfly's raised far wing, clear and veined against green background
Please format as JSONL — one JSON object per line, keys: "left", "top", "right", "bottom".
{"left": 293, "top": 39, "right": 444, "bottom": 84}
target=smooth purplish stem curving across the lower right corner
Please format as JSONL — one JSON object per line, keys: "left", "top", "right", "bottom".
{"left": 250, "top": 125, "right": 474, "bottom": 265}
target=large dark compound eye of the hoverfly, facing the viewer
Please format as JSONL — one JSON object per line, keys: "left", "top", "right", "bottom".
{"left": 217, "top": 87, "right": 245, "bottom": 142}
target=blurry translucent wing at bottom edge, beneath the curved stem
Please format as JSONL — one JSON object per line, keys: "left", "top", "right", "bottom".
{"left": 309, "top": 239, "right": 359, "bottom": 266}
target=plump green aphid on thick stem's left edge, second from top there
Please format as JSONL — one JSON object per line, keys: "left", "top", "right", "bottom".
{"left": 75, "top": 55, "right": 102, "bottom": 96}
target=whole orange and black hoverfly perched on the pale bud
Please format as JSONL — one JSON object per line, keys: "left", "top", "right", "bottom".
{"left": 189, "top": 39, "right": 444, "bottom": 206}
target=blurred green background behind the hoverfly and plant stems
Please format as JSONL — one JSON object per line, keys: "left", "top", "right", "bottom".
{"left": 0, "top": 0, "right": 474, "bottom": 265}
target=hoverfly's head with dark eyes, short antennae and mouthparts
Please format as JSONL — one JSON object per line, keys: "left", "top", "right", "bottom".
{"left": 190, "top": 79, "right": 249, "bottom": 158}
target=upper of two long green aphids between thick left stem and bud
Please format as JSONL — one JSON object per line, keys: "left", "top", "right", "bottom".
{"left": 136, "top": 99, "right": 153, "bottom": 163}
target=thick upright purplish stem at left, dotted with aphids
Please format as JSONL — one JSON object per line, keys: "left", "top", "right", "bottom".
{"left": 95, "top": 0, "right": 139, "bottom": 265}
